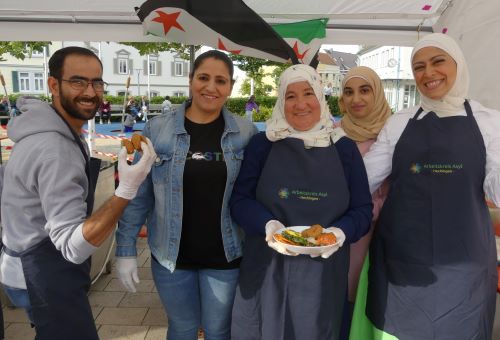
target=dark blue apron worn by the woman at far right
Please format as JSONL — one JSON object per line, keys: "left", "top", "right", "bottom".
{"left": 366, "top": 101, "right": 497, "bottom": 340}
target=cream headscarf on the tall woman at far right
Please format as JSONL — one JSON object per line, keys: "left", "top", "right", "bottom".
{"left": 411, "top": 33, "right": 469, "bottom": 117}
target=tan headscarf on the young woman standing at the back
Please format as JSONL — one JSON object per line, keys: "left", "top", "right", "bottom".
{"left": 339, "top": 66, "right": 392, "bottom": 142}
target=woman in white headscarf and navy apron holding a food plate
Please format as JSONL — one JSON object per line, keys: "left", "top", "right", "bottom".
{"left": 230, "top": 65, "right": 372, "bottom": 340}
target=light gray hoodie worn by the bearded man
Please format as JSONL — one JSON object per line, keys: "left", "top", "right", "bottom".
{"left": 0, "top": 98, "right": 96, "bottom": 288}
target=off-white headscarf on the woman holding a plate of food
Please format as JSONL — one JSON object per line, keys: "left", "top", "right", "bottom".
{"left": 266, "top": 64, "right": 345, "bottom": 148}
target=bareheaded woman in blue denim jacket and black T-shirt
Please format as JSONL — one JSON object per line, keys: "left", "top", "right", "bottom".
{"left": 116, "top": 50, "right": 257, "bottom": 340}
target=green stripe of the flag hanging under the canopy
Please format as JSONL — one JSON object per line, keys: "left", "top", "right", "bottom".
{"left": 271, "top": 19, "right": 328, "bottom": 44}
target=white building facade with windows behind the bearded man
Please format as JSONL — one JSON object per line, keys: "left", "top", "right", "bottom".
{"left": 0, "top": 41, "right": 189, "bottom": 97}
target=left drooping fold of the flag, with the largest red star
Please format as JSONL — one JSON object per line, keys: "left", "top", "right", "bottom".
{"left": 136, "top": 0, "right": 303, "bottom": 63}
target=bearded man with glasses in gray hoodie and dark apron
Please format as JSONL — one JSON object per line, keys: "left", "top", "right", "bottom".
{"left": 0, "top": 47, "right": 156, "bottom": 340}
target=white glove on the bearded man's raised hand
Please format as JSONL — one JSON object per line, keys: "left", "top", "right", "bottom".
{"left": 115, "top": 137, "right": 156, "bottom": 200}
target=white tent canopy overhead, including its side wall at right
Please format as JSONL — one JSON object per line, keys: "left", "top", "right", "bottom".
{"left": 0, "top": 0, "right": 500, "bottom": 109}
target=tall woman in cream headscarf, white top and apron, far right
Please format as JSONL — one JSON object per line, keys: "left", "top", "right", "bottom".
{"left": 358, "top": 33, "right": 500, "bottom": 339}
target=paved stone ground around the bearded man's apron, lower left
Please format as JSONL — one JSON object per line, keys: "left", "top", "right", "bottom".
{"left": 3, "top": 238, "right": 203, "bottom": 340}
